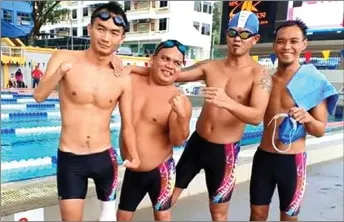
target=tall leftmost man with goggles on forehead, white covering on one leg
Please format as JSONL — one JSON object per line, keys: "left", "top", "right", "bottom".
{"left": 34, "top": 3, "right": 140, "bottom": 221}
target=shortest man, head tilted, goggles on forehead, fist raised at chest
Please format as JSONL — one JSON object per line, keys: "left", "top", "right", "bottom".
{"left": 117, "top": 40, "right": 192, "bottom": 221}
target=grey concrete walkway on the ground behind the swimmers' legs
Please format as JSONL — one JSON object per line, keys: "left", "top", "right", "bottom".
{"left": 134, "top": 159, "right": 343, "bottom": 221}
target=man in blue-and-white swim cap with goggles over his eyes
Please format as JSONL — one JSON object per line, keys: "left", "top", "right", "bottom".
{"left": 133, "top": 11, "right": 271, "bottom": 221}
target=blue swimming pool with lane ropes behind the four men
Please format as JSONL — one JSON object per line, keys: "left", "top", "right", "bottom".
{"left": 1, "top": 91, "right": 342, "bottom": 183}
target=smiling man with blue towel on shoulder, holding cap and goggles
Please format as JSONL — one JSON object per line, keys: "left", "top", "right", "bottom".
{"left": 250, "top": 21, "right": 336, "bottom": 221}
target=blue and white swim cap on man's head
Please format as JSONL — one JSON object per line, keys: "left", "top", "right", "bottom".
{"left": 228, "top": 11, "right": 259, "bottom": 34}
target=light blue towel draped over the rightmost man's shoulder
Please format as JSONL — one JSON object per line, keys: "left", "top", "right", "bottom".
{"left": 287, "top": 64, "right": 338, "bottom": 114}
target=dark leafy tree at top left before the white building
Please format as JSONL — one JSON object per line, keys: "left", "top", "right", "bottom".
{"left": 28, "top": 0, "right": 69, "bottom": 45}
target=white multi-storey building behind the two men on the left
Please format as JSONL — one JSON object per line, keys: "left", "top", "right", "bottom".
{"left": 41, "top": 0, "right": 213, "bottom": 59}
